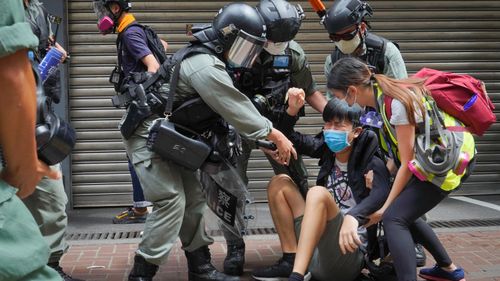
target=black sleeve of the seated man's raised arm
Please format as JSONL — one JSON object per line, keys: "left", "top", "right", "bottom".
{"left": 277, "top": 113, "right": 325, "bottom": 158}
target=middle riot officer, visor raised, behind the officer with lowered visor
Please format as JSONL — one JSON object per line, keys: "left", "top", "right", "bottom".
{"left": 222, "top": 0, "right": 326, "bottom": 275}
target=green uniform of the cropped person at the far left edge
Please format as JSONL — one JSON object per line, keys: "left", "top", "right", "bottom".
{"left": 0, "top": 0, "right": 61, "bottom": 281}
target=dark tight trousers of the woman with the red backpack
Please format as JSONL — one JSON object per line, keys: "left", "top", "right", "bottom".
{"left": 383, "top": 177, "right": 451, "bottom": 281}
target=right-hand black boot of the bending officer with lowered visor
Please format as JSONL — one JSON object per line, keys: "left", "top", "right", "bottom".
{"left": 184, "top": 246, "right": 240, "bottom": 281}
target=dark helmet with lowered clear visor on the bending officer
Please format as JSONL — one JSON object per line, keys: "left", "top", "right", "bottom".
{"left": 212, "top": 3, "right": 266, "bottom": 68}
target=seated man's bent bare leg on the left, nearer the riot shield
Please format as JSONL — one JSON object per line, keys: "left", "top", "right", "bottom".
{"left": 267, "top": 174, "right": 305, "bottom": 253}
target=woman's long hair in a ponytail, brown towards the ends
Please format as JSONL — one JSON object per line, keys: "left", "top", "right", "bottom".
{"left": 327, "top": 57, "right": 428, "bottom": 125}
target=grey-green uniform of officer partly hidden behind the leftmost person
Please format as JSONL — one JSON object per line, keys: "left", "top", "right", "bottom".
{"left": 23, "top": 0, "right": 68, "bottom": 263}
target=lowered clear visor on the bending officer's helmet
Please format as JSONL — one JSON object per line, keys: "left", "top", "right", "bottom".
{"left": 227, "top": 30, "right": 266, "bottom": 68}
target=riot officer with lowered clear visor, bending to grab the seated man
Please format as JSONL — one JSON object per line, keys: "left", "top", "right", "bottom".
{"left": 94, "top": 3, "right": 295, "bottom": 280}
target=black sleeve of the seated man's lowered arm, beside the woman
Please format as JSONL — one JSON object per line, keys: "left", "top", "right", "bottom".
{"left": 347, "top": 156, "right": 390, "bottom": 225}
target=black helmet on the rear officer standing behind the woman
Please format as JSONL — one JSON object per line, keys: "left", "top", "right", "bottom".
{"left": 324, "top": 0, "right": 373, "bottom": 34}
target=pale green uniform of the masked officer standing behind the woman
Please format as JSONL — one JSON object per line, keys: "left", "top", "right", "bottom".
{"left": 324, "top": 31, "right": 408, "bottom": 99}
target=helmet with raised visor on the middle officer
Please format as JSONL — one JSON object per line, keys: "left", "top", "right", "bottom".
{"left": 257, "top": 0, "right": 304, "bottom": 42}
